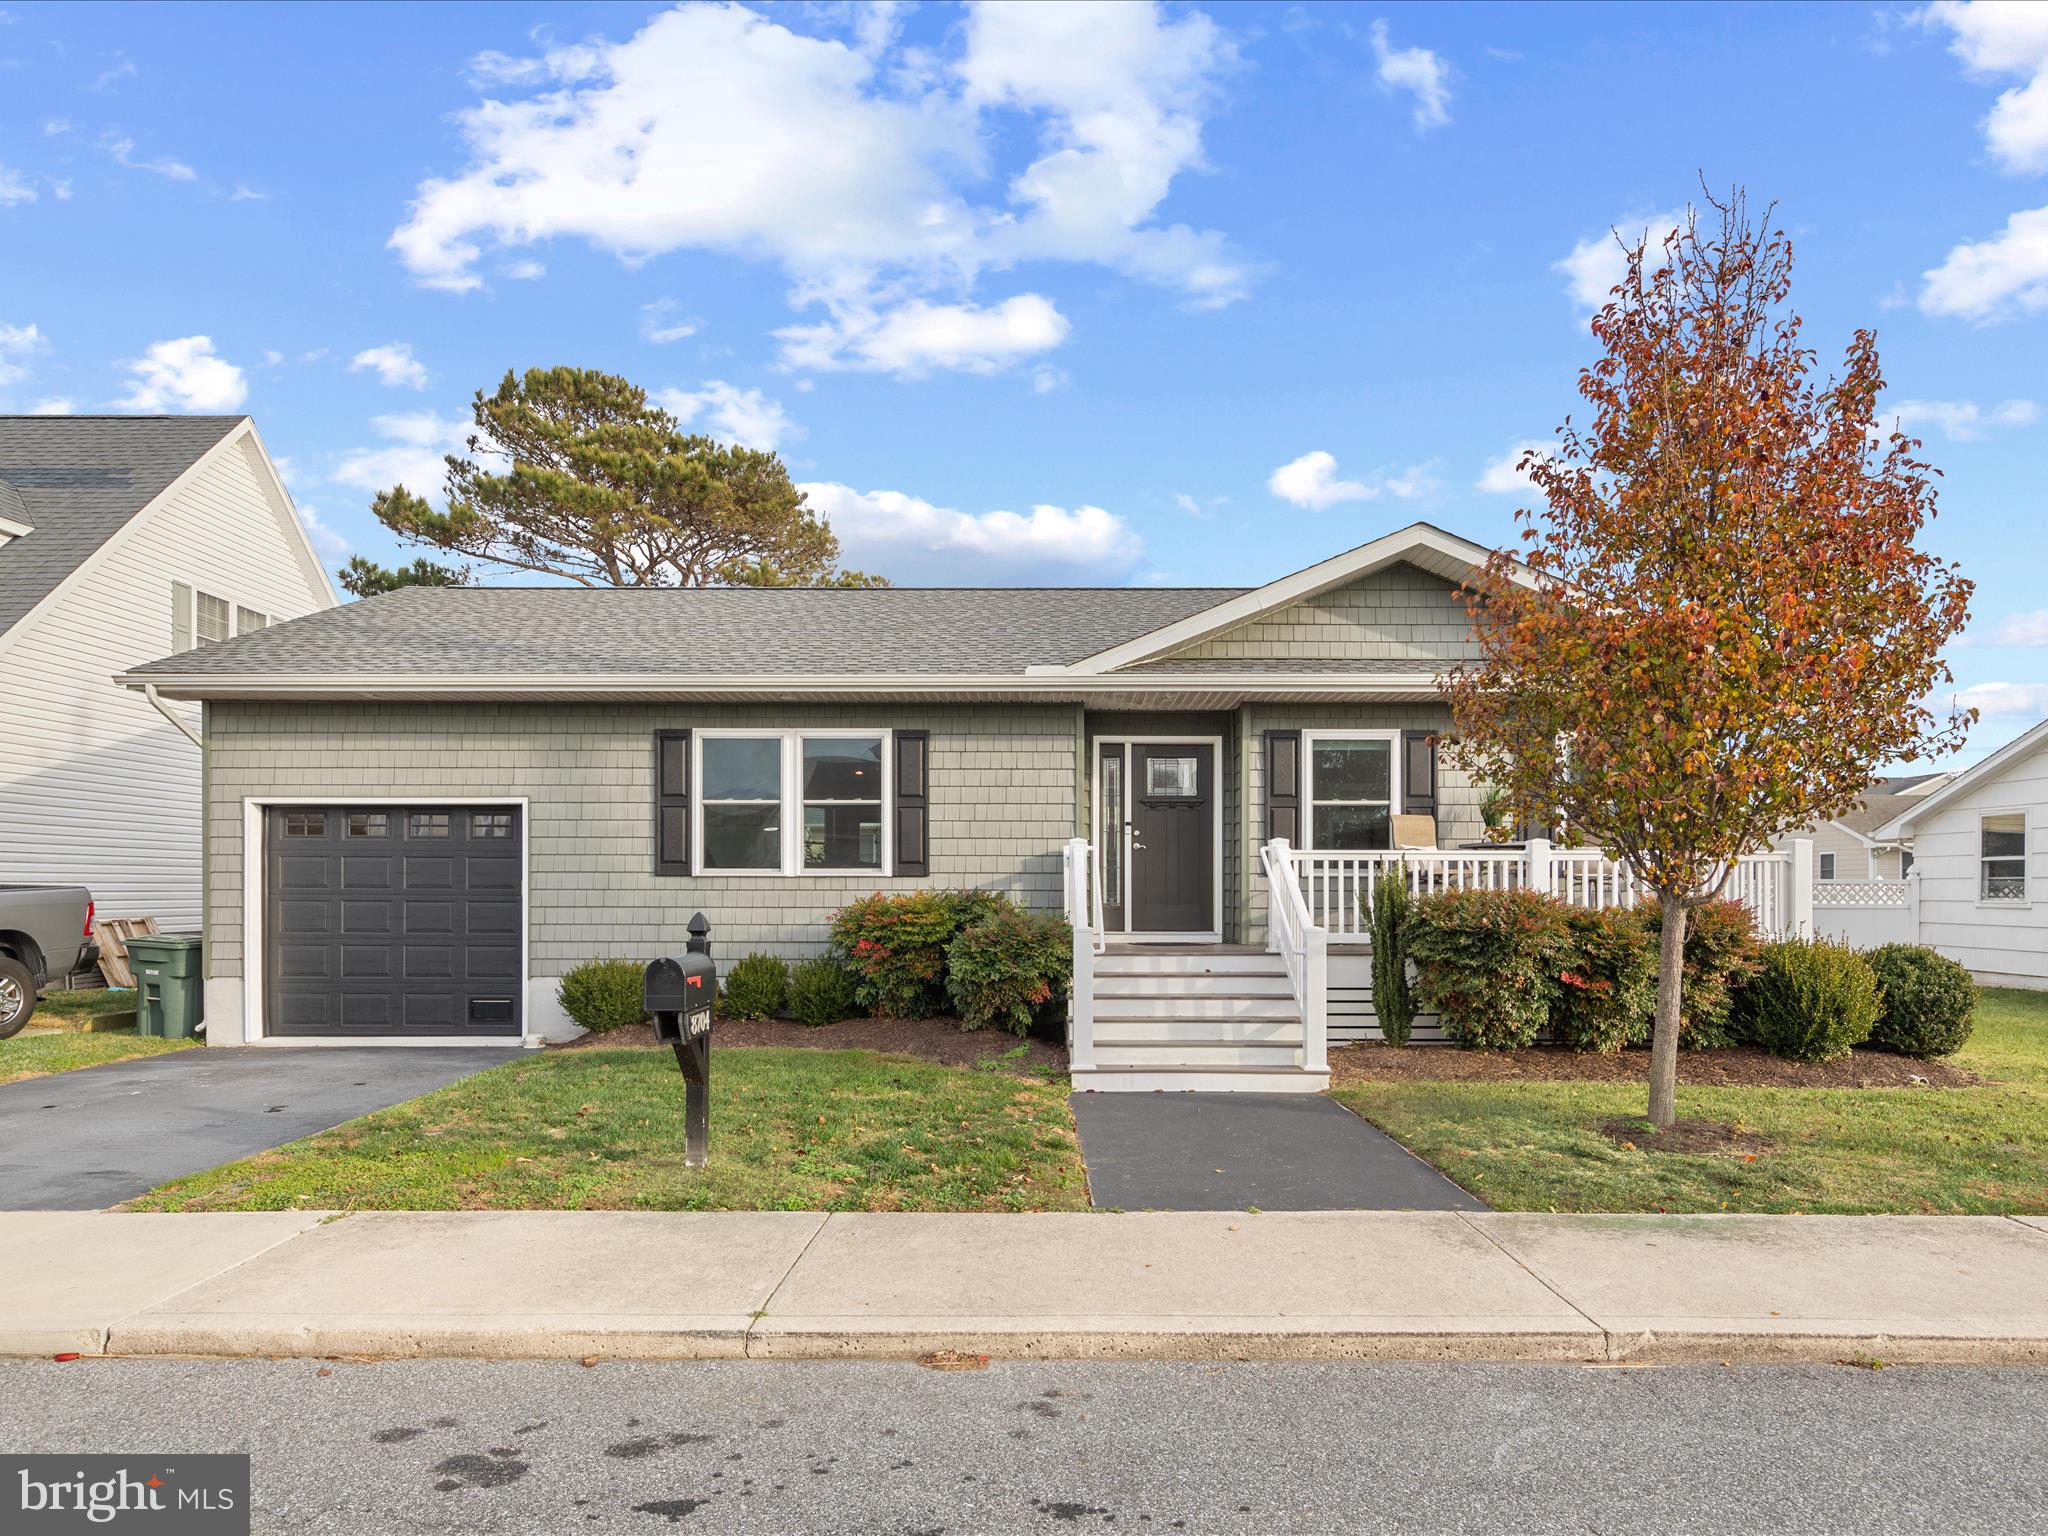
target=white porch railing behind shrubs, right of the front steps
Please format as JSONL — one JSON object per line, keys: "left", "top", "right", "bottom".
{"left": 1266, "top": 838, "right": 1815, "bottom": 940}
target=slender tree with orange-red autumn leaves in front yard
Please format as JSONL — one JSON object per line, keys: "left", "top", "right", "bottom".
{"left": 1444, "top": 193, "right": 1974, "bottom": 1128}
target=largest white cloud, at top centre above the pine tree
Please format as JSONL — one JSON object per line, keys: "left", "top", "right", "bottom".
{"left": 391, "top": 4, "right": 1249, "bottom": 367}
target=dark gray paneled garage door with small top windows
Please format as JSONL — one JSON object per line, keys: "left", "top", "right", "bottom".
{"left": 264, "top": 805, "right": 526, "bottom": 1034}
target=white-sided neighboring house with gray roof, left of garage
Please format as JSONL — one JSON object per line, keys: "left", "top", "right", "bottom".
{"left": 0, "top": 416, "right": 336, "bottom": 932}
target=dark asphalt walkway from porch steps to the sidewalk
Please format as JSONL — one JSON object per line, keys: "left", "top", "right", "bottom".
{"left": 1073, "top": 1094, "right": 1487, "bottom": 1210}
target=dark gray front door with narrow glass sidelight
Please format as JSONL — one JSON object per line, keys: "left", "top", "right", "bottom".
{"left": 1096, "top": 741, "right": 1217, "bottom": 934}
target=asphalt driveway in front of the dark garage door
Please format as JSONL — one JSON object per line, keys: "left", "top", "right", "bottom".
{"left": 0, "top": 1047, "right": 507, "bottom": 1210}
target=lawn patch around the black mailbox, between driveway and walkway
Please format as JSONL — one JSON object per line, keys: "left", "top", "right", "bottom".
{"left": 129, "top": 1049, "right": 1087, "bottom": 1210}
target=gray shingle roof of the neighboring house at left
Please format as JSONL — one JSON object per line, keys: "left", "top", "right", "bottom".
{"left": 0, "top": 416, "right": 244, "bottom": 633}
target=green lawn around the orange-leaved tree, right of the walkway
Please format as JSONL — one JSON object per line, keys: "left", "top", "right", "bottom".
{"left": 1335, "top": 991, "right": 2048, "bottom": 1214}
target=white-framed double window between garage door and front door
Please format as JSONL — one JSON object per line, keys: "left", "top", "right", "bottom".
{"left": 692, "top": 729, "right": 891, "bottom": 874}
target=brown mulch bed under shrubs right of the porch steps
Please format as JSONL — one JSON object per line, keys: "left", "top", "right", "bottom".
{"left": 1329, "top": 1042, "right": 1985, "bottom": 1087}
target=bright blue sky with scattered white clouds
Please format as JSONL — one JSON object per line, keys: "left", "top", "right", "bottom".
{"left": 0, "top": 0, "right": 2048, "bottom": 756}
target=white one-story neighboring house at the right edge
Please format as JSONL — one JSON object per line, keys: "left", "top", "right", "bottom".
{"left": 1876, "top": 721, "right": 2048, "bottom": 991}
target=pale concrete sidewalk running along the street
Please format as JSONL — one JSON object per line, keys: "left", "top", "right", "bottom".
{"left": 16, "top": 1210, "right": 2048, "bottom": 1362}
